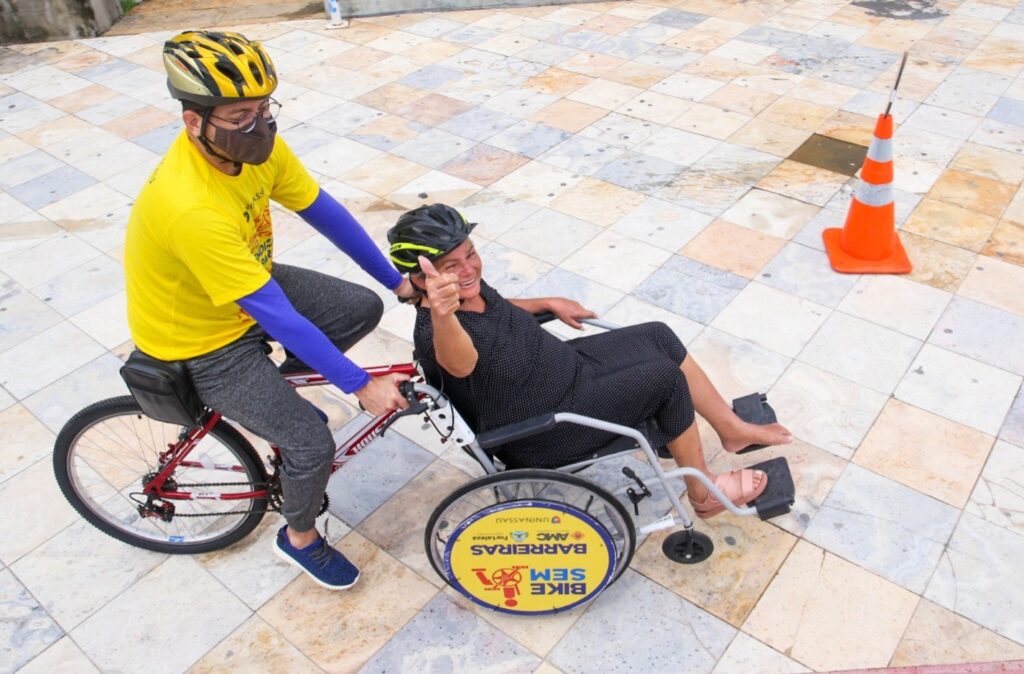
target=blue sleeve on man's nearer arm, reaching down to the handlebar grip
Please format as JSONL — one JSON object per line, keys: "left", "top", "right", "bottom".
{"left": 238, "top": 279, "right": 370, "bottom": 393}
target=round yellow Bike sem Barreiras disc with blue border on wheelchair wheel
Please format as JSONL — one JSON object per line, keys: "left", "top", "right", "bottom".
{"left": 444, "top": 501, "right": 615, "bottom": 615}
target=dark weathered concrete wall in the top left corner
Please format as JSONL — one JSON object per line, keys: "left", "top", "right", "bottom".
{"left": 0, "top": 0, "right": 121, "bottom": 44}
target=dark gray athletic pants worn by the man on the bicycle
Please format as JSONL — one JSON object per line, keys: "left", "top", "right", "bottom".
{"left": 185, "top": 263, "right": 384, "bottom": 532}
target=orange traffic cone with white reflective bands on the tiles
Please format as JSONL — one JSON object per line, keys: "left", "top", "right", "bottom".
{"left": 821, "top": 114, "right": 910, "bottom": 273}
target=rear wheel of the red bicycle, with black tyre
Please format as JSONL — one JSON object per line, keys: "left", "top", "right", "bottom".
{"left": 53, "top": 396, "right": 267, "bottom": 554}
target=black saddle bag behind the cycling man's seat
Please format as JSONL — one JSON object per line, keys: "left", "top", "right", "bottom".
{"left": 121, "top": 350, "right": 203, "bottom": 426}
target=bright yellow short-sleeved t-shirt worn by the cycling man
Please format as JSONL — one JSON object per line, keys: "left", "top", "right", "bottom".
{"left": 125, "top": 131, "right": 319, "bottom": 361}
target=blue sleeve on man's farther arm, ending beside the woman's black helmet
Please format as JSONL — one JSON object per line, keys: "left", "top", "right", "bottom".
{"left": 289, "top": 189, "right": 401, "bottom": 288}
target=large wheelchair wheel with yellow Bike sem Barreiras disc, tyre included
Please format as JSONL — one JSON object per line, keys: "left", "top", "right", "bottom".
{"left": 425, "top": 469, "right": 636, "bottom": 615}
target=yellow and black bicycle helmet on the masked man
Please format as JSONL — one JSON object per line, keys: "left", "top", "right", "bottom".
{"left": 164, "top": 31, "right": 278, "bottom": 107}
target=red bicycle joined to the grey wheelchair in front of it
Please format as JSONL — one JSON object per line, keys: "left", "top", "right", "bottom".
{"left": 53, "top": 321, "right": 794, "bottom": 614}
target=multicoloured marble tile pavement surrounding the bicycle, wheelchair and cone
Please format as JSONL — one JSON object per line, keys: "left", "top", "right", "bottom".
{"left": 0, "top": 0, "right": 1024, "bottom": 674}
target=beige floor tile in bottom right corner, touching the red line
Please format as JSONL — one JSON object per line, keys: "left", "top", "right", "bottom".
{"left": 890, "top": 599, "right": 1024, "bottom": 667}
